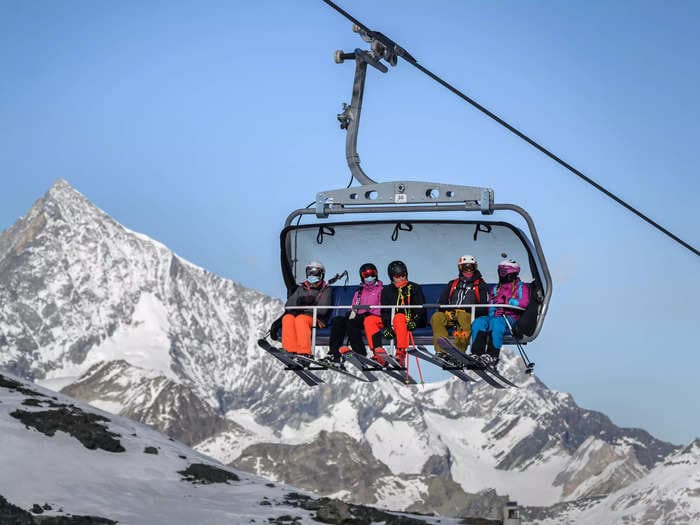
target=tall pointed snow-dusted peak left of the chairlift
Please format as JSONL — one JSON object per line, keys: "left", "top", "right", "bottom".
{"left": 0, "top": 180, "right": 280, "bottom": 397}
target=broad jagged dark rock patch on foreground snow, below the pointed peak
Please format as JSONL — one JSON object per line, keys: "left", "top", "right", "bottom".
{"left": 10, "top": 407, "right": 124, "bottom": 452}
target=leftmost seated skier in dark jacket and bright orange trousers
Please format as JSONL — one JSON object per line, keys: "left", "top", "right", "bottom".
{"left": 282, "top": 261, "right": 331, "bottom": 356}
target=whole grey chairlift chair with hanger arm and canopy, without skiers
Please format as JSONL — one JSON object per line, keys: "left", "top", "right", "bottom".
{"left": 261, "top": 10, "right": 552, "bottom": 384}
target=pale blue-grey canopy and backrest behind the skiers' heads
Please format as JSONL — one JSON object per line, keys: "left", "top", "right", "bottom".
{"left": 280, "top": 211, "right": 551, "bottom": 344}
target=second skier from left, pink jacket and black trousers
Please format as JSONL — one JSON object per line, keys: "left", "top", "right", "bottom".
{"left": 326, "top": 263, "right": 384, "bottom": 364}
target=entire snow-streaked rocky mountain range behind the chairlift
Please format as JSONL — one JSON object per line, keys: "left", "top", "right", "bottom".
{"left": 0, "top": 181, "right": 696, "bottom": 518}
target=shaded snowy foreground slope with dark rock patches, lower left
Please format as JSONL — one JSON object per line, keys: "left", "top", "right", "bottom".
{"left": 0, "top": 368, "right": 448, "bottom": 525}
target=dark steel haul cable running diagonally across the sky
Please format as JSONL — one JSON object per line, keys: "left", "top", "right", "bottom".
{"left": 323, "top": 0, "right": 700, "bottom": 256}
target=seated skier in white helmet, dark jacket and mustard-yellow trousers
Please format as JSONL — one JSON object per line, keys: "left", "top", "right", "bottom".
{"left": 430, "top": 255, "right": 488, "bottom": 354}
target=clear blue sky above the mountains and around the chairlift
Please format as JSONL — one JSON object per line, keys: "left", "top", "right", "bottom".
{"left": 0, "top": 0, "right": 700, "bottom": 443}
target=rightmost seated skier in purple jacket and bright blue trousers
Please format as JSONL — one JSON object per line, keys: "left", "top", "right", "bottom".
{"left": 471, "top": 259, "right": 530, "bottom": 365}
